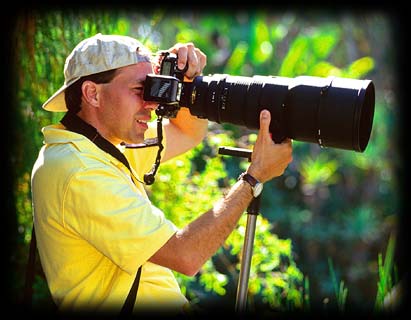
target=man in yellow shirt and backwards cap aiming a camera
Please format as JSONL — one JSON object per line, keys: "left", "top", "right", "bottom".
{"left": 32, "top": 34, "right": 292, "bottom": 314}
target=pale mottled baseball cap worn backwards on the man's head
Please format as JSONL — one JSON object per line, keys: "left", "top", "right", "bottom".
{"left": 43, "top": 33, "right": 151, "bottom": 112}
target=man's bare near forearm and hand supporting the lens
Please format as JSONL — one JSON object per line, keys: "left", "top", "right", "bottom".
{"left": 149, "top": 111, "right": 292, "bottom": 275}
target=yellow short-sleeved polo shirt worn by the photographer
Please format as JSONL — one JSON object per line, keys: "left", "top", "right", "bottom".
{"left": 32, "top": 124, "right": 188, "bottom": 313}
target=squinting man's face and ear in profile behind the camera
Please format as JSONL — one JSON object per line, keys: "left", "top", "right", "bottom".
{"left": 98, "top": 62, "right": 157, "bottom": 144}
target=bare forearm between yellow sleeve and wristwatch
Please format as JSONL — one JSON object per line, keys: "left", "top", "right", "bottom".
{"left": 150, "top": 181, "right": 252, "bottom": 275}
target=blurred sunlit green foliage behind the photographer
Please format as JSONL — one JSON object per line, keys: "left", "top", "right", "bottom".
{"left": 7, "top": 7, "right": 408, "bottom": 313}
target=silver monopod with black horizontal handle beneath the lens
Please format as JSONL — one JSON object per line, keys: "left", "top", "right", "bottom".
{"left": 218, "top": 147, "right": 261, "bottom": 313}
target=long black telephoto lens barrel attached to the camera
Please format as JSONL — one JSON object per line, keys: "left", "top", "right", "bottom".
{"left": 180, "top": 74, "right": 375, "bottom": 152}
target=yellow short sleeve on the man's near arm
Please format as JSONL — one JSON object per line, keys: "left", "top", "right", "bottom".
{"left": 63, "top": 162, "right": 177, "bottom": 274}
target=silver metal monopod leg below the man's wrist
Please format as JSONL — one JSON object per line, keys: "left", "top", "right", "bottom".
{"left": 235, "top": 196, "right": 261, "bottom": 313}
